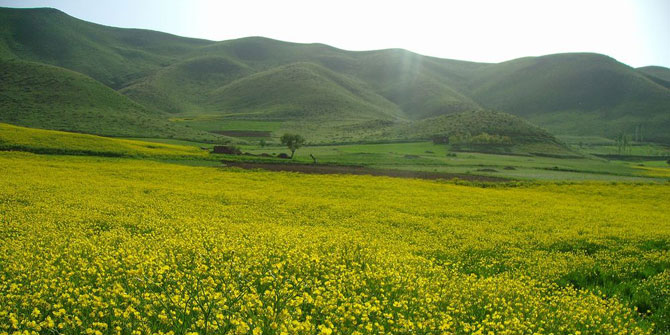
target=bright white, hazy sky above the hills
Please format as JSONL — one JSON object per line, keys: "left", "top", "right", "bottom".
{"left": 0, "top": 0, "right": 670, "bottom": 67}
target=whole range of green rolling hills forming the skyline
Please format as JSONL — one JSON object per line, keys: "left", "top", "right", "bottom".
{"left": 0, "top": 8, "right": 670, "bottom": 143}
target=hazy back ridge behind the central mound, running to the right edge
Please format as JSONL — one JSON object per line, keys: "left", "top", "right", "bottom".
{"left": 196, "top": 38, "right": 670, "bottom": 142}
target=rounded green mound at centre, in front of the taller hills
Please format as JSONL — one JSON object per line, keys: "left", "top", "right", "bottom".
{"left": 210, "top": 63, "right": 401, "bottom": 120}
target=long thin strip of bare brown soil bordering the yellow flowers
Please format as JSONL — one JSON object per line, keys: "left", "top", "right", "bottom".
{"left": 223, "top": 161, "right": 510, "bottom": 182}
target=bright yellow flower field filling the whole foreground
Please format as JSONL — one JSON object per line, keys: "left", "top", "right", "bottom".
{"left": 0, "top": 153, "right": 670, "bottom": 335}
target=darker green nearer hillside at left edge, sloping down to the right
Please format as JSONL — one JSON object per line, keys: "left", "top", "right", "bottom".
{"left": 0, "top": 60, "right": 227, "bottom": 141}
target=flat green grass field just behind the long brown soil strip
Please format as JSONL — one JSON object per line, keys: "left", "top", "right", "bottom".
{"left": 228, "top": 142, "right": 670, "bottom": 182}
